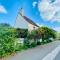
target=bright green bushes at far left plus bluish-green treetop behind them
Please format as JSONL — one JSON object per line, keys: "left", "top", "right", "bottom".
{"left": 0, "top": 25, "right": 20, "bottom": 58}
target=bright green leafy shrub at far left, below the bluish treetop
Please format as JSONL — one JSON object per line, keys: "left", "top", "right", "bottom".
{"left": 0, "top": 29, "right": 15, "bottom": 57}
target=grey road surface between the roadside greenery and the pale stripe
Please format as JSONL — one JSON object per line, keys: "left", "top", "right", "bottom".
{"left": 3, "top": 41, "right": 60, "bottom": 60}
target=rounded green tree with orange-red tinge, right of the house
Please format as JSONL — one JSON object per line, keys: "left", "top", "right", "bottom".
{"left": 37, "top": 27, "right": 56, "bottom": 41}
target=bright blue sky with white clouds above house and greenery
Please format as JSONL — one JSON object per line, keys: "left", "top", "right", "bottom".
{"left": 0, "top": 0, "right": 60, "bottom": 31}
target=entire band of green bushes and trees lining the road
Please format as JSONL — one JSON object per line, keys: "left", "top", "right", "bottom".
{"left": 0, "top": 24, "right": 56, "bottom": 58}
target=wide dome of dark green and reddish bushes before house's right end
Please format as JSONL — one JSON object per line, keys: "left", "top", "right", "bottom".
{"left": 28, "top": 27, "right": 56, "bottom": 43}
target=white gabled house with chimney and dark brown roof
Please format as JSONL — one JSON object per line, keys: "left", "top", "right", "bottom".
{"left": 14, "top": 8, "right": 39, "bottom": 32}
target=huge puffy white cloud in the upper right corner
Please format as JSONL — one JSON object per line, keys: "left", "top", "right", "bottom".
{"left": 38, "top": 0, "right": 60, "bottom": 22}
